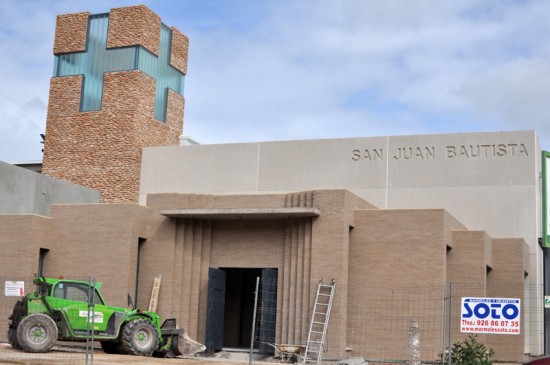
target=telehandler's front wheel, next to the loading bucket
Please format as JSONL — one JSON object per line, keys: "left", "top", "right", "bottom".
{"left": 122, "top": 318, "right": 159, "bottom": 356}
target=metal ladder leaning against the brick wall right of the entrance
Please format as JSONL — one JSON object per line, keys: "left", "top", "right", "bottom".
{"left": 302, "top": 278, "right": 336, "bottom": 365}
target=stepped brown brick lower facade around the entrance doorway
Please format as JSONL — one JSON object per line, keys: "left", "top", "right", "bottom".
{"left": 0, "top": 190, "right": 529, "bottom": 361}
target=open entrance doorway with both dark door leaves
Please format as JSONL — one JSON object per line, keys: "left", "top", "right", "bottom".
{"left": 206, "top": 268, "right": 277, "bottom": 353}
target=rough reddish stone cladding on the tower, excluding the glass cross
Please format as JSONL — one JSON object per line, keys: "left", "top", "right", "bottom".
{"left": 43, "top": 6, "right": 188, "bottom": 203}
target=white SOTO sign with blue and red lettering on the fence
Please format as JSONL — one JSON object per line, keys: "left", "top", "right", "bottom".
{"left": 460, "top": 297, "right": 521, "bottom": 335}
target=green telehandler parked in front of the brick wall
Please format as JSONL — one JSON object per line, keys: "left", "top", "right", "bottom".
{"left": 8, "top": 276, "right": 183, "bottom": 357}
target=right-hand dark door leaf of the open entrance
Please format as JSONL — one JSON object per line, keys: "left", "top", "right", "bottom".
{"left": 259, "top": 269, "right": 277, "bottom": 354}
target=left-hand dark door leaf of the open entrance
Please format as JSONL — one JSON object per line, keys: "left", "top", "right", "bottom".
{"left": 205, "top": 268, "right": 225, "bottom": 352}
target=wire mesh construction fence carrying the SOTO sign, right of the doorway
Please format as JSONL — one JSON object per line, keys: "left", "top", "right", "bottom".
{"left": 250, "top": 278, "right": 544, "bottom": 364}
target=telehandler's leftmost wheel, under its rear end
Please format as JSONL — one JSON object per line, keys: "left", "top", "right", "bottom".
{"left": 17, "top": 313, "right": 57, "bottom": 352}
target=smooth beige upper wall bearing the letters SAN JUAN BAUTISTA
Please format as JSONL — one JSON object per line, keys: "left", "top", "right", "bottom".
{"left": 140, "top": 131, "right": 540, "bottom": 250}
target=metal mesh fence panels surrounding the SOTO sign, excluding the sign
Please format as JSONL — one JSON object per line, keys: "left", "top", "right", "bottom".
{"left": 251, "top": 280, "right": 544, "bottom": 364}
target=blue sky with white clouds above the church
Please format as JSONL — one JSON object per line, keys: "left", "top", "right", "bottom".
{"left": 0, "top": 0, "right": 550, "bottom": 162}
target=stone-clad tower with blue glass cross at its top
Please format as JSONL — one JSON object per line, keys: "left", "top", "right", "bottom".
{"left": 42, "top": 5, "right": 189, "bottom": 203}
